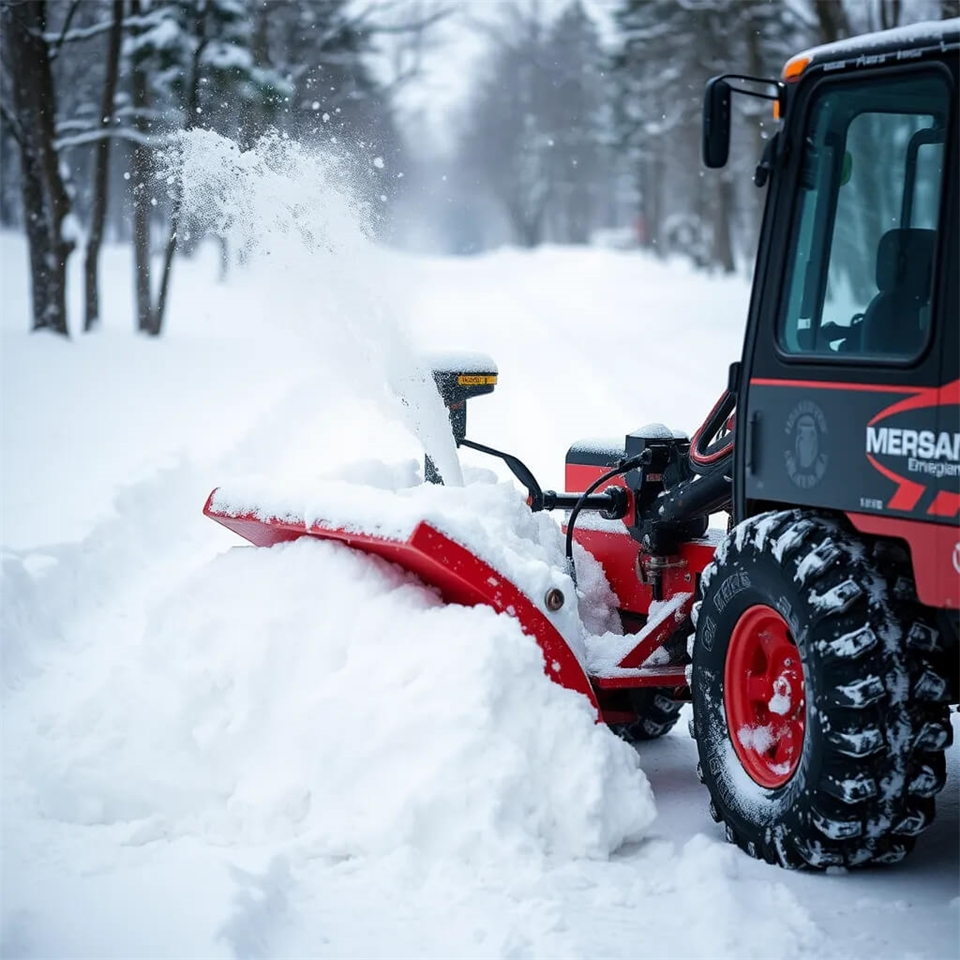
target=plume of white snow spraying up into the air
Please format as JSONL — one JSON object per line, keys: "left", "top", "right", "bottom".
{"left": 169, "top": 130, "right": 463, "bottom": 485}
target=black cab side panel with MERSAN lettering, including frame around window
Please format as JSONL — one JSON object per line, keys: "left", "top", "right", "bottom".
{"left": 734, "top": 35, "right": 960, "bottom": 523}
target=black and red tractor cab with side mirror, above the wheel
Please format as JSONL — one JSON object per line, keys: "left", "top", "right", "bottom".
{"left": 704, "top": 20, "right": 960, "bottom": 609}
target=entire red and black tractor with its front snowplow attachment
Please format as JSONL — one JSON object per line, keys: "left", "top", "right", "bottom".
{"left": 206, "top": 20, "right": 960, "bottom": 868}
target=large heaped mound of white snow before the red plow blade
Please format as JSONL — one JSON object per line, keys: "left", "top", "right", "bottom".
{"left": 5, "top": 528, "right": 654, "bottom": 862}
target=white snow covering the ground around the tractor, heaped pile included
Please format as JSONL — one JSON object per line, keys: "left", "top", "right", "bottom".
{"left": 0, "top": 144, "right": 960, "bottom": 958}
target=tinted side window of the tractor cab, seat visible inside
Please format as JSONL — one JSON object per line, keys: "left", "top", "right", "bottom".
{"left": 779, "top": 72, "right": 950, "bottom": 361}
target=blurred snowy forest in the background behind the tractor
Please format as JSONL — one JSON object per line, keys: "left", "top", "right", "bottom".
{"left": 0, "top": 0, "right": 960, "bottom": 335}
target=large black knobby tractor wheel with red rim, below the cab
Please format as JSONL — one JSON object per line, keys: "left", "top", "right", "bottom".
{"left": 690, "top": 510, "right": 952, "bottom": 869}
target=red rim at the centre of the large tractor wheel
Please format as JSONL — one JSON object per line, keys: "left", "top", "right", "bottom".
{"left": 723, "top": 604, "right": 807, "bottom": 787}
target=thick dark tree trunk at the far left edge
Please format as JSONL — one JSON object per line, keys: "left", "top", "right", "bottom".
{"left": 2, "top": 0, "right": 73, "bottom": 336}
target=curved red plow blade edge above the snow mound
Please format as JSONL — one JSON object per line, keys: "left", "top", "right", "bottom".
{"left": 203, "top": 490, "right": 599, "bottom": 711}
